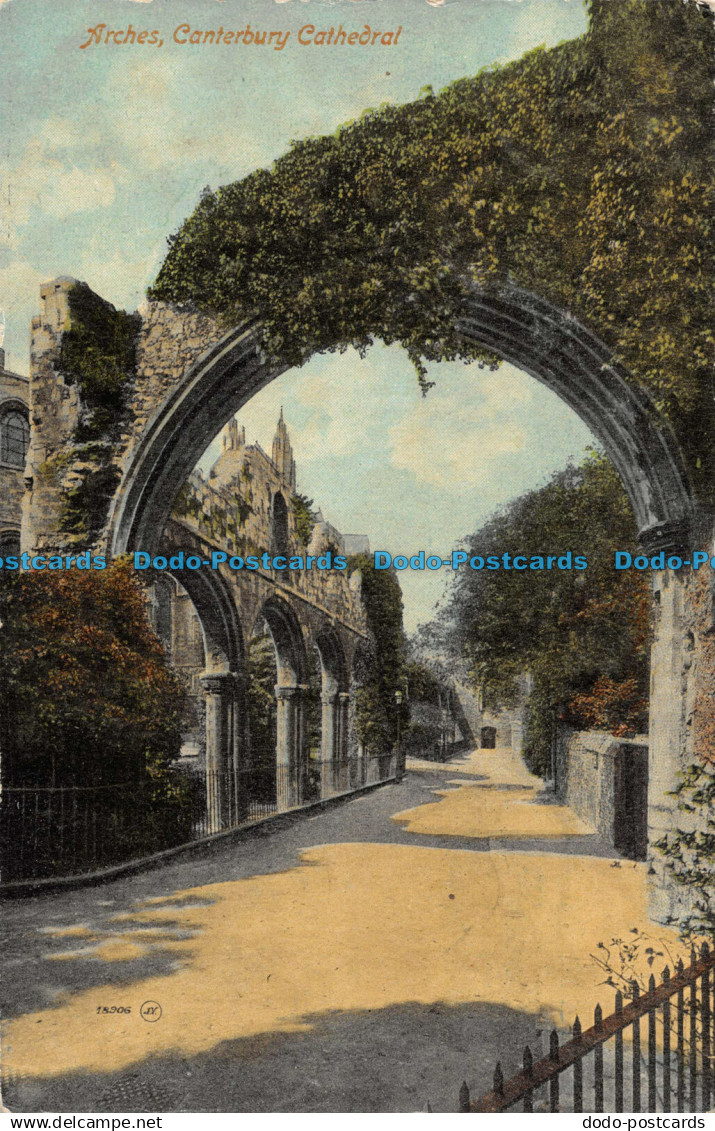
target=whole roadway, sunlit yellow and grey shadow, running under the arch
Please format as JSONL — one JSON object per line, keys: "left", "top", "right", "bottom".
{"left": 2, "top": 751, "right": 660, "bottom": 1112}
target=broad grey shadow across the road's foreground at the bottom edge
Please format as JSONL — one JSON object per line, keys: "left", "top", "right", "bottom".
{"left": 5, "top": 999, "right": 545, "bottom": 1112}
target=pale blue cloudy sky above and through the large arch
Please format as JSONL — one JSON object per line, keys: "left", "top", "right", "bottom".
{"left": 0, "top": 0, "right": 591, "bottom": 627}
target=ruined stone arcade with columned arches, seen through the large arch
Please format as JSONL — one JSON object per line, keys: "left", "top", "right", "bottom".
{"left": 147, "top": 413, "right": 369, "bottom": 831}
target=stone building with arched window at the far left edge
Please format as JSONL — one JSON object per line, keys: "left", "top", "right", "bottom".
{"left": 0, "top": 349, "right": 29, "bottom": 558}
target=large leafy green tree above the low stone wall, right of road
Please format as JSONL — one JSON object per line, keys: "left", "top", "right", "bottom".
{"left": 442, "top": 455, "right": 649, "bottom": 772}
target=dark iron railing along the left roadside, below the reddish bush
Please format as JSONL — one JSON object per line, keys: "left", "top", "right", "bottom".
{"left": 0, "top": 756, "right": 396, "bottom": 883}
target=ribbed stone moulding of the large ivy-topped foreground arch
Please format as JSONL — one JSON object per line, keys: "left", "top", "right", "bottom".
{"left": 106, "top": 287, "right": 694, "bottom": 554}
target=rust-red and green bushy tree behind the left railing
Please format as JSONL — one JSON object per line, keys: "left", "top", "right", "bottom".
{"left": 0, "top": 560, "right": 186, "bottom": 791}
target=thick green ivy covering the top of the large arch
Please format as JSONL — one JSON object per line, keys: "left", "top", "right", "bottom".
{"left": 150, "top": 0, "right": 714, "bottom": 477}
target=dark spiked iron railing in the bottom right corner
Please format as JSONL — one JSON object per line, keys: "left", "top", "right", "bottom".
{"left": 459, "top": 943, "right": 715, "bottom": 1113}
